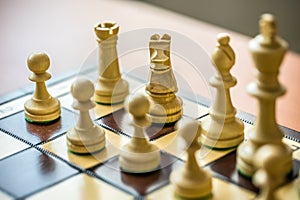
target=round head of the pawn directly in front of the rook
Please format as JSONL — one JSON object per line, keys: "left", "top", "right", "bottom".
{"left": 71, "top": 78, "right": 95, "bottom": 102}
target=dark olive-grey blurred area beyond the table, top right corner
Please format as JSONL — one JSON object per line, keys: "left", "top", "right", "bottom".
{"left": 141, "top": 0, "right": 300, "bottom": 53}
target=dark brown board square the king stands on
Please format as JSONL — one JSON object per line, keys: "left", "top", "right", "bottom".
{"left": 207, "top": 151, "right": 300, "bottom": 193}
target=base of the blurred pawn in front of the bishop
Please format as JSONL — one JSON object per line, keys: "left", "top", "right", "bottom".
{"left": 170, "top": 168, "right": 212, "bottom": 199}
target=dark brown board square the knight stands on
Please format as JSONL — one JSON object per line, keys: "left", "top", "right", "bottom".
{"left": 97, "top": 108, "right": 175, "bottom": 140}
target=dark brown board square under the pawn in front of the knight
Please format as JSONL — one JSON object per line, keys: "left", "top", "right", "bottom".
{"left": 91, "top": 152, "right": 183, "bottom": 196}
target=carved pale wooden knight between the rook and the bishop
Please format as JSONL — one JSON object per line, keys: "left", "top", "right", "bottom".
{"left": 146, "top": 34, "right": 182, "bottom": 124}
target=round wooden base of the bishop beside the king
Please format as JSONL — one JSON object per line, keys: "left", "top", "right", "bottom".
{"left": 200, "top": 118, "right": 244, "bottom": 150}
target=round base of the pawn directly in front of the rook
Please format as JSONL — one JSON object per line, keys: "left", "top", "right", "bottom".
{"left": 67, "top": 126, "right": 105, "bottom": 154}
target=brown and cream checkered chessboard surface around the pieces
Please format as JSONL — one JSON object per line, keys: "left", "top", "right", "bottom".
{"left": 0, "top": 66, "right": 300, "bottom": 200}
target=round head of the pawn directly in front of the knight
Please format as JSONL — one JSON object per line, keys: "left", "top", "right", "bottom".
{"left": 128, "top": 94, "right": 150, "bottom": 118}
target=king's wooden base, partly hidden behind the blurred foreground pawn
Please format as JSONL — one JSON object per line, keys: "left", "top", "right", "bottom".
{"left": 237, "top": 140, "right": 293, "bottom": 178}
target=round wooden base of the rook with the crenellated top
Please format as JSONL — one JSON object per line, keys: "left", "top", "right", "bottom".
{"left": 94, "top": 79, "right": 129, "bottom": 105}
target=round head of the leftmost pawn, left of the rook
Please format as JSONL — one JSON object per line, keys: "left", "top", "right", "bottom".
{"left": 27, "top": 52, "right": 50, "bottom": 74}
